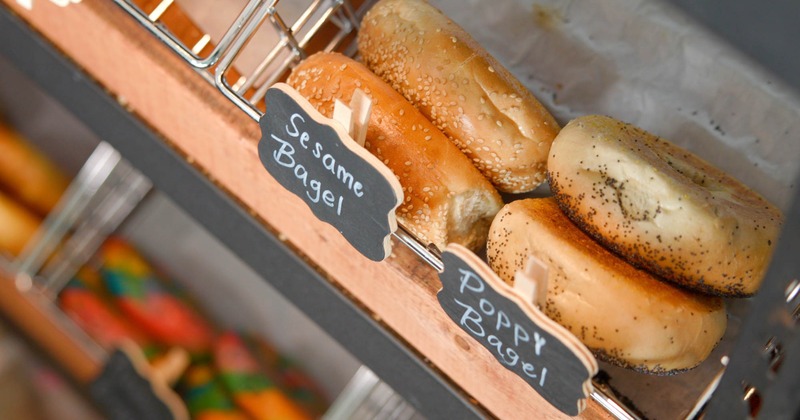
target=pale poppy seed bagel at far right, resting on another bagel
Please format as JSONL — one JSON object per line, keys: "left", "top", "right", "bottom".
{"left": 548, "top": 115, "right": 782, "bottom": 297}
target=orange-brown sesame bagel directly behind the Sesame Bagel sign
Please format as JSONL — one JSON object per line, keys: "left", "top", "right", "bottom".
{"left": 287, "top": 53, "right": 503, "bottom": 250}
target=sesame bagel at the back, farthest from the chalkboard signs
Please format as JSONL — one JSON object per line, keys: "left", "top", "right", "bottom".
{"left": 358, "top": 0, "right": 559, "bottom": 193}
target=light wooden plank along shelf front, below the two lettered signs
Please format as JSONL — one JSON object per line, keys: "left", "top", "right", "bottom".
{"left": 3, "top": 0, "right": 608, "bottom": 418}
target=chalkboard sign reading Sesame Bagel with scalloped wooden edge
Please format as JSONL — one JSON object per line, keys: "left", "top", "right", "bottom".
{"left": 258, "top": 83, "right": 403, "bottom": 261}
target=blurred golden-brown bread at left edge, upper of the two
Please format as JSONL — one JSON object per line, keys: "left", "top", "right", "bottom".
{"left": 0, "top": 124, "right": 69, "bottom": 216}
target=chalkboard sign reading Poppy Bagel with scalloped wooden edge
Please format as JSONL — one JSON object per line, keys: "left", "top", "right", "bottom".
{"left": 437, "top": 244, "right": 598, "bottom": 416}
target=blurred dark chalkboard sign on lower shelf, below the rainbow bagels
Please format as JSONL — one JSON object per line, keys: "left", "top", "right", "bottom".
{"left": 89, "top": 350, "right": 188, "bottom": 420}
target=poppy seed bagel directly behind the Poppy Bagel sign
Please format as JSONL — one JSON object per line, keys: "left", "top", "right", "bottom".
{"left": 487, "top": 198, "right": 727, "bottom": 374}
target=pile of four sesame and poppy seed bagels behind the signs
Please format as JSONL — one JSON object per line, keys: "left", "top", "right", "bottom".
{"left": 287, "top": 0, "right": 782, "bottom": 374}
